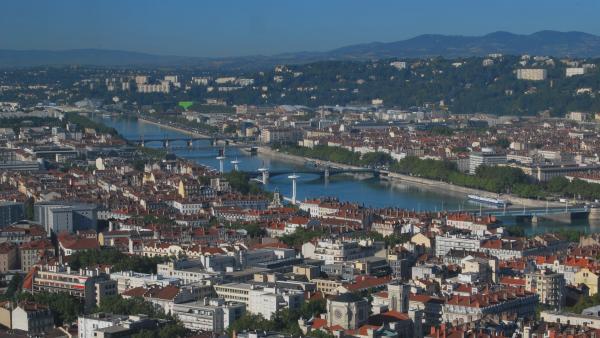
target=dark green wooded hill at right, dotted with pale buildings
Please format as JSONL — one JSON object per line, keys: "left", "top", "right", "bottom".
{"left": 199, "top": 56, "right": 600, "bottom": 115}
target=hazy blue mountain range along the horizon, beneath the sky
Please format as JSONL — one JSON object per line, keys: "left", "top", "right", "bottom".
{"left": 0, "top": 31, "right": 600, "bottom": 69}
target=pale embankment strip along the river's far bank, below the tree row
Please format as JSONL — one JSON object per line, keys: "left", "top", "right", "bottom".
{"left": 258, "top": 146, "right": 564, "bottom": 207}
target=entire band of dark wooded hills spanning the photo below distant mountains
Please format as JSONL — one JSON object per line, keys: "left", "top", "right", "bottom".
{"left": 0, "top": 55, "right": 600, "bottom": 116}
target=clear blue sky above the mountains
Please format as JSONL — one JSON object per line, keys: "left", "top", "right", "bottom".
{"left": 0, "top": 0, "right": 600, "bottom": 56}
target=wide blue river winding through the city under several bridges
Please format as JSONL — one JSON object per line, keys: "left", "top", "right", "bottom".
{"left": 95, "top": 116, "right": 600, "bottom": 234}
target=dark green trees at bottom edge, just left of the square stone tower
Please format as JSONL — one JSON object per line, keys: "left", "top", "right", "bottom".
{"left": 227, "top": 299, "right": 328, "bottom": 338}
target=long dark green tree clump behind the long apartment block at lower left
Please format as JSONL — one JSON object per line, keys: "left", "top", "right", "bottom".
{"left": 69, "top": 249, "right": 166, "bottom": 273}
